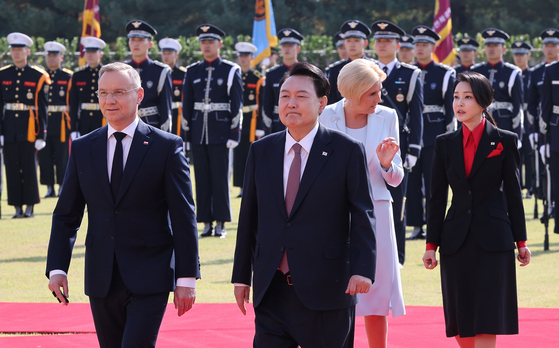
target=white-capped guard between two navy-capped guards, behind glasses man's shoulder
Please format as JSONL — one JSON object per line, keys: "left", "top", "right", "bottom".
{"left": 159, "top": 39, "right": 186, "bottom": 140}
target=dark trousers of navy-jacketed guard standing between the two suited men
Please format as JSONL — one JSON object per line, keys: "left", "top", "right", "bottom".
{"left": 192, "top": 144, "right": 231, "bottom": 222}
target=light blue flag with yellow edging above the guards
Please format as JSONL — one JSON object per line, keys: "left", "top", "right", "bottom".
{"left": 252, "top": 0, "right": 278, "bottom": 67}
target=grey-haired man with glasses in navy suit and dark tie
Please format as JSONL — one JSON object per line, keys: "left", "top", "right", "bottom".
{"left": 46, "top": 63, "right": 200, "bottom": 347}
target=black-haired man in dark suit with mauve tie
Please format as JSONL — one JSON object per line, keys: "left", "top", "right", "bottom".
{"left": 232, "top": 63, "right": 376, "bottom": 347}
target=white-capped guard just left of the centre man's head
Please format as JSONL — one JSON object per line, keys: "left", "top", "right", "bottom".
{"left": 233, "top": 42, "right": 265, "bottom": 197}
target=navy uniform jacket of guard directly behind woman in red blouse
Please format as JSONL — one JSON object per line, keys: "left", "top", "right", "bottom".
{"left": 471, "top": 61, "right": 524, "bottom": 139}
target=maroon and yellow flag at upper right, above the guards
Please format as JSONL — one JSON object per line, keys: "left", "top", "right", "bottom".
{"left": 433, "top": 0, "right": 456, "bottom": 65}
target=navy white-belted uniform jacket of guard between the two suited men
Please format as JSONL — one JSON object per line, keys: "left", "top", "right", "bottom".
{"left": 183, "top": 57, "right": 243, "bottom": 145}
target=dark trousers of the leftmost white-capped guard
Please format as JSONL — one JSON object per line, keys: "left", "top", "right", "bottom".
{"left": 4, "top": 141, "right": 41, "bottom": 206}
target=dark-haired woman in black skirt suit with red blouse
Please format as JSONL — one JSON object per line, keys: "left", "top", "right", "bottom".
{"left": 423, "top": 73, "right": 531, "bottom": 348}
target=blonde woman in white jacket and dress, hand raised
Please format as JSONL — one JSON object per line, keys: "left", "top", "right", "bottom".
{"left": 319, "top": 59, "right": 405, "bottom": 347}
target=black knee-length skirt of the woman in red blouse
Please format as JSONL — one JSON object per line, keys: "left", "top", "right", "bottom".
{"left": 440, "top": 233, "right": 518, "bottom": 337}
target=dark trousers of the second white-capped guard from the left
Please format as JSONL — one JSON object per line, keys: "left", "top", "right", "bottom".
{"left": 39, "top": 135, "right": 69, "bottom": 186}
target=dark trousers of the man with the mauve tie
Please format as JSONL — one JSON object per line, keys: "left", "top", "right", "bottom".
{"left": 254, "top": 271, "right": 355, "bottom": 348}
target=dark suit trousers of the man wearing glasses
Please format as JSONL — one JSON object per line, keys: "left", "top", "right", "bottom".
{"left": 89, "top": 262, "right": 169, "bottom": 348}
